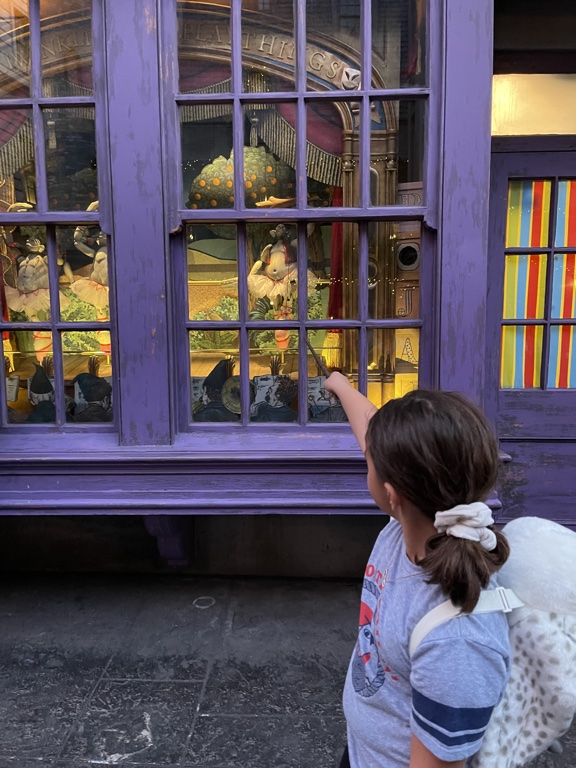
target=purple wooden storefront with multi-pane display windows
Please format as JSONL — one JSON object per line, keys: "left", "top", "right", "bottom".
{"left": 0, "top": 0, "right": 576, "bottom": 573}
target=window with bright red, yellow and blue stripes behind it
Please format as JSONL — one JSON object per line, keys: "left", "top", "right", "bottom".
{"left": 500, "top": 179, "right": 576, "bottom": 389}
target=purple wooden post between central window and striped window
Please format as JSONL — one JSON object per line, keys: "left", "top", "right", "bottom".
{"left": 439, "top": 0, "right": 493, "bottom": 402}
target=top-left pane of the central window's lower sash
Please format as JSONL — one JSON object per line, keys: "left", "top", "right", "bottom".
{"left": 186, "top": 224, "right": 238, "bottom": 322}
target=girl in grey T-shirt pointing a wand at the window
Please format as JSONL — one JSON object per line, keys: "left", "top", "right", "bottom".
{"left": 325, "top": 373, "right": 510, "bottom": 768}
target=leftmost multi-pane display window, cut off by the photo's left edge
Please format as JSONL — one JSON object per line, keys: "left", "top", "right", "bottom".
{"left": 0, "top": 0, "right": 114, "bottom": 429}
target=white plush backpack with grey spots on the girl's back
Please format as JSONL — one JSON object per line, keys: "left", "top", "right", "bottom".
{"left": 410, "top": 517, "right": 576, "bottom": 768}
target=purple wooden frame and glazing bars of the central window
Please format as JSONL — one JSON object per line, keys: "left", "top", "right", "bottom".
{"left": 161, "top": 0, "right": 437, "bottom": 438}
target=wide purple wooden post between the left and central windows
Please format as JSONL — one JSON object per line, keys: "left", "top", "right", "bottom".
{"left": 106, "top": 0, "right": 171, "bottom": 445}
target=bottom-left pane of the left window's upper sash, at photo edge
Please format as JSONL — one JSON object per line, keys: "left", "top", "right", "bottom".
{"left": 0, "top": 109, "right": 36, "bottom": 212}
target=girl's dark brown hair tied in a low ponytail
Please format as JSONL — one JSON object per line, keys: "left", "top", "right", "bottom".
{"left": 366, "top": 390, "right": 510, "bottom": 612}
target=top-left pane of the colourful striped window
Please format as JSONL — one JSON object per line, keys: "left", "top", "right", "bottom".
{"left": 506, "top": 179, "right": 552, "bottom": 248}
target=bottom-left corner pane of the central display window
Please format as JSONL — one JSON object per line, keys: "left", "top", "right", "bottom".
{"left": 190, "top": 330, "right": 241, "bottom": 423}
